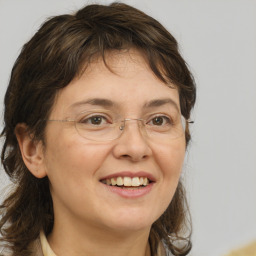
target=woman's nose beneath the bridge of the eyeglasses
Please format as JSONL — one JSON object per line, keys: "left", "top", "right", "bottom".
{"left": 113, "top": 119, "right": 152, "bottom": 162}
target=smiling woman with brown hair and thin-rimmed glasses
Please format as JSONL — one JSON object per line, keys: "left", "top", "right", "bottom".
{"left": 0, "top": 3, "right": 196, "bottom": 256}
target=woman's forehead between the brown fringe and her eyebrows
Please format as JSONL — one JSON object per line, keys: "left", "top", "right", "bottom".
{"left": 49, "top": 50, "right": 180, "bottom": 116}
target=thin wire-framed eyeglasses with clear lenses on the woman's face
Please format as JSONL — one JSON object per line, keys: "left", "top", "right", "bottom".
{"left": 47, "top": 110, "right": 193, "bottom": 142}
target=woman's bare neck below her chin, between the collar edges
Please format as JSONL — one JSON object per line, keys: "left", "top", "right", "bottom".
{"left": 48, "top": 220, "right": 150, "bottom": 256}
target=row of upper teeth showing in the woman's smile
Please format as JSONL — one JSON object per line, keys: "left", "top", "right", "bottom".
{"left": 102, "top": 177, "right": 149, "bottom": 187}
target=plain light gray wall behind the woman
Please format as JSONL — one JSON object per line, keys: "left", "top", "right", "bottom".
{"left": 0, "top": 0, "right": 256, "bottom": 256}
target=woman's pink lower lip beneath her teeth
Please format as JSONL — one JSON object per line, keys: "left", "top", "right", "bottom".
{"left": 102, "top": 183, "right": 154, "bottom": 198}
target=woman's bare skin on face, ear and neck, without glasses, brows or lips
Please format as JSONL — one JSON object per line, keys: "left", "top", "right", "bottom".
{"left": 16, "top": 50, "right": 185, "bottom": 256}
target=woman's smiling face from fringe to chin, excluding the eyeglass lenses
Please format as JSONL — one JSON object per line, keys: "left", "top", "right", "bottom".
{"left": 43, "top": 51, "right": 185, "bottom": 234}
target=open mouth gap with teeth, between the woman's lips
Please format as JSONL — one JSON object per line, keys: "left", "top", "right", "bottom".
{"left": 100, "top": 176, "right": 153, "bottom": 189}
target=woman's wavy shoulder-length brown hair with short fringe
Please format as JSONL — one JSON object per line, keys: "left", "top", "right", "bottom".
{"left": 0, "top": 3, "right": 196, "bottom": 256}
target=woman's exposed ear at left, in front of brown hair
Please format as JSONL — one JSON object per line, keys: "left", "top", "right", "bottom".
{"left": 15, "top": 123, "right": 46, "bottom": 178}
